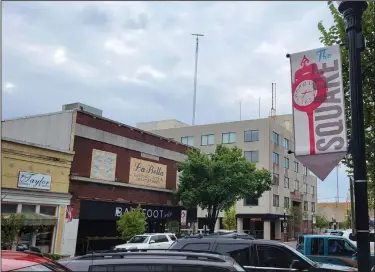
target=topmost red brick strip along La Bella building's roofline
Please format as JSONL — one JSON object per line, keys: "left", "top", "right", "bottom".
{"left": 76, "top": 111, "right": 189, "bottom": 153}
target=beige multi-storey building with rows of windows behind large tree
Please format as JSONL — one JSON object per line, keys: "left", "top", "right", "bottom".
{"left": 140, "top": 115, "right": 317, "bottom": 240}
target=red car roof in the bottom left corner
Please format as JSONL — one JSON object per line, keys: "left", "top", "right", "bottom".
{"left": 1, "top": 250, "right": 51, "bottom": 271}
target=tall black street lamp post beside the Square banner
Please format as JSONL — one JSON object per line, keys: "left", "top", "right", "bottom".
{"left": 338, "top": 1, "right": 370, "bottom": 272}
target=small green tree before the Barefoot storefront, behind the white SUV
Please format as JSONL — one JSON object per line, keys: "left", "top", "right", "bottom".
{"left": 117, "top": 205, "right": 146, "bottom": 240}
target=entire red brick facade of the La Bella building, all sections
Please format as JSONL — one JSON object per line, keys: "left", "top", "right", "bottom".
{"left": 69, "top": 112, "right": 188, "bottom": 218}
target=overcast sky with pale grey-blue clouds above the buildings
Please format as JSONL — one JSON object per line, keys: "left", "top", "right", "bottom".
{"left": 2, "top": 1, "right": 348, "bottom": 204}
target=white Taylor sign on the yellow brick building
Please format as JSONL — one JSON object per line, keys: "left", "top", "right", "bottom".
{"left": 18, "top": 171, "right": 52, "bottom": 190}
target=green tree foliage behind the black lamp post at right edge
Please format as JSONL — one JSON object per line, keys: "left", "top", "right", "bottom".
{"left": 318, "top": 1, "right": 375, "bottom": 207}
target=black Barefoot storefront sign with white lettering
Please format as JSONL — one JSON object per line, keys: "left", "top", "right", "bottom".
{"left": 79, "top": 200, "right": 183, "bottom": 221}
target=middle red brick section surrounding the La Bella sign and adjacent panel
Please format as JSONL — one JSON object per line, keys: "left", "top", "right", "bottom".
{"left": 71, "top": 136, "right": 181, "bottom": 190}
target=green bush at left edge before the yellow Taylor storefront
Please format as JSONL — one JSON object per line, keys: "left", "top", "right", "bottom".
{"left": 1, "top": 214, "right": 25, "bottom": 249}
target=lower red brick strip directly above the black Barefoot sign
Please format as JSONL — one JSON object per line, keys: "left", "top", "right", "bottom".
{"left": 69, "top": 180, "right": 177, "bottom": 219}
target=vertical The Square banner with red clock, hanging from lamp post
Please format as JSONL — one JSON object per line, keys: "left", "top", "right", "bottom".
{"left": 290, "top": 45, "right": 348, "bottom": 180}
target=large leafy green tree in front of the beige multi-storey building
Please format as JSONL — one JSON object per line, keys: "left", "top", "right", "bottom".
{"left": 177, "top": 145, "right": 271, "bottom": 232}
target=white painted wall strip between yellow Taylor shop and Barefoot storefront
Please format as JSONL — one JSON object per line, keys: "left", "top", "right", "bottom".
{"left": 61, "top": 219, "right": 79, "bottom": 257}
